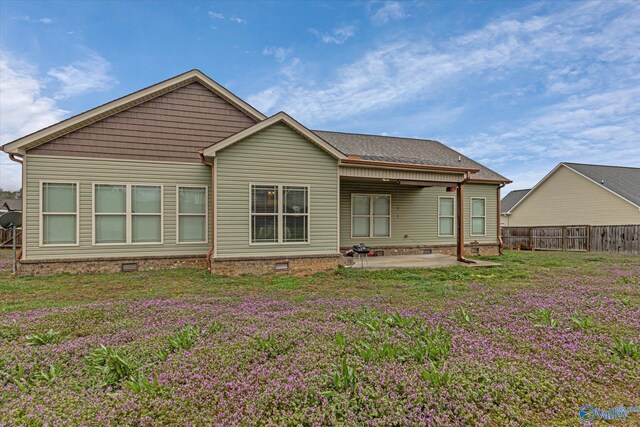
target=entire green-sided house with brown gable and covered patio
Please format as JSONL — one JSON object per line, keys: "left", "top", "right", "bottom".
{"left": 3, "top": 70, "right": 509, "bottom": 274}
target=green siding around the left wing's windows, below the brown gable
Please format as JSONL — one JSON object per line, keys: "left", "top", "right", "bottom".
{"left": 25, "top": 155, "right": 211, "bottom": 260}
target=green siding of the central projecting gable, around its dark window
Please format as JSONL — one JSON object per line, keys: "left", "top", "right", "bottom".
{"left": 214, "top": 124, "right": 338, "bottom": 258}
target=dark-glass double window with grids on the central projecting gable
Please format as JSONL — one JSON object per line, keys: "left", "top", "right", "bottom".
{"left": 250, "top": 185, "right": 309, "bottom": 243}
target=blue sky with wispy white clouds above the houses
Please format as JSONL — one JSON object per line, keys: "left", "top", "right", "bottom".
{"left": 0, "top": 0, "right": 640, "bottom": 193}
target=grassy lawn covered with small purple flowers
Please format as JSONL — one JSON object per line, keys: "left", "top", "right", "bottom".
{"left": 0, "top": 252, "right": 640, "bottom": 426}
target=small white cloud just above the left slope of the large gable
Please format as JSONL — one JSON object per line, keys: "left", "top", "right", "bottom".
{"left": 47, "top": 53, "right": 118, "bottom": 99}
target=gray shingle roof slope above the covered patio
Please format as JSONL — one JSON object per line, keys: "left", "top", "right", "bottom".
{"left": 313, "top": 130, "right": 510, "bottom": 182}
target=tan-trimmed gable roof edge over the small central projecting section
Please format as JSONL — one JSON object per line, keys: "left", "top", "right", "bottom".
{"left": 202, "top": 111, "right": 346, "bottom": 159}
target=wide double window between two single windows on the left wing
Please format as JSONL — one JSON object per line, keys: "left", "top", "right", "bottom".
{"left": 93, "top": 184, "right": 162, "bottom": 245}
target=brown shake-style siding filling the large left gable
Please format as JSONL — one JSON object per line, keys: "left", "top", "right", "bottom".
{"left": 28, "top": 83, "right": 255, "bottom": 163}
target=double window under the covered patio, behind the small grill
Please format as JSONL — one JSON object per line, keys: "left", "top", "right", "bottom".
{"left": 351, "top": 194, "right": 391, "bottom": 237}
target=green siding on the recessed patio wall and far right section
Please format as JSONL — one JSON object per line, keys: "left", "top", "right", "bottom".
{"left": 340, "top": 180, "right": 498, "bottom": 248}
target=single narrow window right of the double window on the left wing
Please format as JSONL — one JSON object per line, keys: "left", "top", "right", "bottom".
{"left": 178, "top": 187, "right": 208, "bottom": 243}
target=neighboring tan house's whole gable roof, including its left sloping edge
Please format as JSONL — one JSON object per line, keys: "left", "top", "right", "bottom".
{"left": 503, "top": 162, "right": 640, "bottom": 213}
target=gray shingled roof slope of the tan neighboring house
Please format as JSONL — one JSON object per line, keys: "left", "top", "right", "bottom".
{"left": 563, "top": 162, "right": 640, "bottom": 206}
